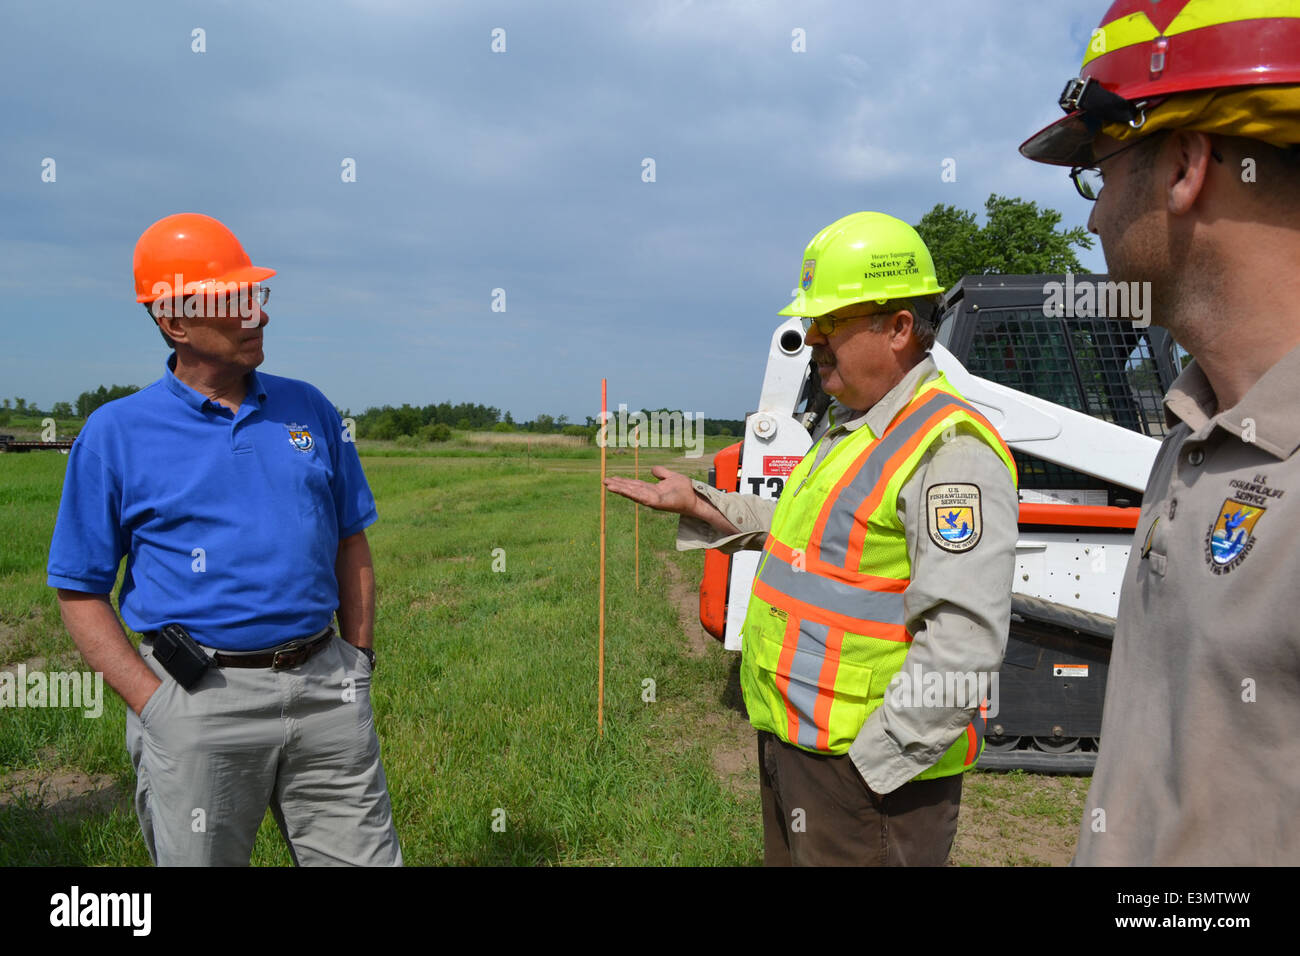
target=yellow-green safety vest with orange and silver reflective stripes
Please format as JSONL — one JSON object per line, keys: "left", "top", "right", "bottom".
{"left": 741, "top": 375, "right": 1015, "bottom": 779}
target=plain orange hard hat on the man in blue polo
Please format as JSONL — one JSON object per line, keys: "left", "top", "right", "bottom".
{"left": 131, "top": 212, "right": 276, "bottom": 302}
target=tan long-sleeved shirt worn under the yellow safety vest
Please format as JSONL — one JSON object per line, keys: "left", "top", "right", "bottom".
{"left": 677, "top": 355, "right": 1019, "bottom": 793}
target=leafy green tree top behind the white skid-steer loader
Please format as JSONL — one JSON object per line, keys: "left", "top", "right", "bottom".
{"left": 917, "top": 193, "right": 1093, "bottom": 289}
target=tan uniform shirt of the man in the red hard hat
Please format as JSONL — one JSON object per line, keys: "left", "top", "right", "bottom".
{"left": 1074, "top": 349, "right": 1300, "bottom": 866}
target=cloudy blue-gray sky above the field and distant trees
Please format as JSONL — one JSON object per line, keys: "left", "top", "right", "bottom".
{"left": 0, "top": 0, "right": 1108, "bottom": 421}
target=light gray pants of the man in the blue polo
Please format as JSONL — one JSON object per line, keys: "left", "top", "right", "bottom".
{"left": 126, "top": 636, "right": 402, "bottom": 866}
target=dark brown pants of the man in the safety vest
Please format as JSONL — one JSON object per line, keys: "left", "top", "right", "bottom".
{"left": 758, "top": 731, "right": 962, "bottom": 866}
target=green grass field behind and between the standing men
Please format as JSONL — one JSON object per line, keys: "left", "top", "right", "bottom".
{"left": 0, "top": 436, "right": 1086, "bottom": 865}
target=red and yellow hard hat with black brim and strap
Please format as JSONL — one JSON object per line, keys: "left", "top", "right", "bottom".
{"left": 1021, "top": 0, "right": 1300, "bottom": 166}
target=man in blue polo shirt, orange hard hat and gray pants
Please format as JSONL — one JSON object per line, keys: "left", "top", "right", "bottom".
{"left": 48, "top": 213, "right": 402, "bottom": 865}
